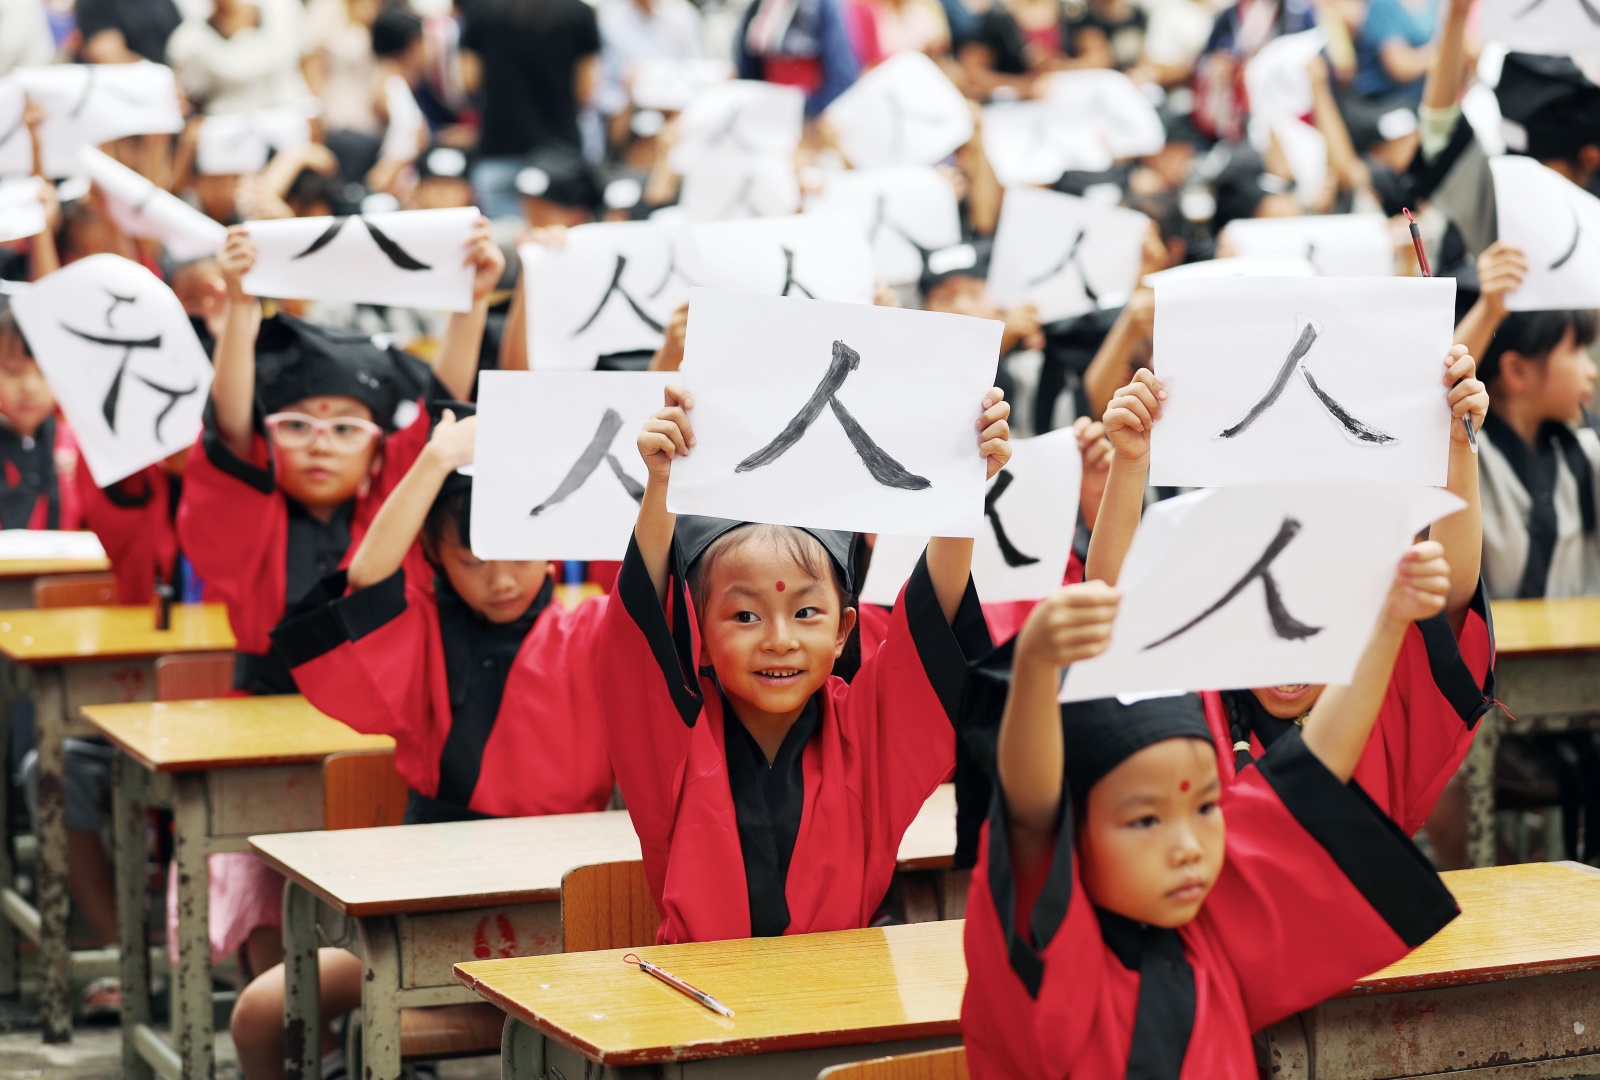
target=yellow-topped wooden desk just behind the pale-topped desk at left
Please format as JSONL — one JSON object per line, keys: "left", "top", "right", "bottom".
{"left": 83, "top": 694, "right": 394, "bottom": 1080}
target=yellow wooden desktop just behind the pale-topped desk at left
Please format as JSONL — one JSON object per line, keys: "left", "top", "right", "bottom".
{"left": 83, "top": 694, "right": 394, "bottom": 773}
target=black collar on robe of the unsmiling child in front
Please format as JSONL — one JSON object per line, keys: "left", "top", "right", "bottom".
{"left": 1094, "top": 907, "right": 1195, "bottom": 1080}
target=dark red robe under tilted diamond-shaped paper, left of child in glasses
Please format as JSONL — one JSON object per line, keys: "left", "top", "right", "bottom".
{"left": 77, "top": 466, "right": 178, "bottom": 603}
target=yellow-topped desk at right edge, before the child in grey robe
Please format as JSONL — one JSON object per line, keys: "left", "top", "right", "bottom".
{"left": 1466, "top": 597, "right": 1600, "bottom": 866}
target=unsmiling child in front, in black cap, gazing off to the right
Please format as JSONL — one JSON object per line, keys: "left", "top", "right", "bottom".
{"left": 962, "top": 553, "right": 1456, "bottom": 1080}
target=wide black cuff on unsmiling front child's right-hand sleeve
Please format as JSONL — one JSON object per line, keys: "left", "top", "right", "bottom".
{"left": 1256, "top": 731, "right": 1459, "bottom": 949}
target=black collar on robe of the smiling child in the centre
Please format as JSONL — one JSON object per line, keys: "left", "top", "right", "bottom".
{"left": 722, "top": 694, "right": 822, "bottom": 938}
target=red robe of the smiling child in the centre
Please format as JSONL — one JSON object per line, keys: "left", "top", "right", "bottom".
{"left": 597, "top": 541, "right": 987, "bottom": 944}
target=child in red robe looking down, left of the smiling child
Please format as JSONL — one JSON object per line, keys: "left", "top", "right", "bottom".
{"left": 232, "top": 406, "right": 611, "bottom": 1080}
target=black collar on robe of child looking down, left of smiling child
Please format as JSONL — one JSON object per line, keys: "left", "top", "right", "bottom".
{"left": 435, "top": 574, "right": 555, "bottom": 810}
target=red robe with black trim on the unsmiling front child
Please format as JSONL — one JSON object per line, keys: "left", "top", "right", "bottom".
{"left": 962, "top": 736, "right": 1456, "bottom": 1080}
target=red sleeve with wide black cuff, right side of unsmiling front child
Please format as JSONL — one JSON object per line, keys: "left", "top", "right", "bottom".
{"left": 1195, "top": 731, "right": 1458, "bottom": 1030}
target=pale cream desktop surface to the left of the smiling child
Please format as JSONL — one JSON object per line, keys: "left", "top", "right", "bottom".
{"left": 250, "top": 810, "right": 640, "bottom": 915}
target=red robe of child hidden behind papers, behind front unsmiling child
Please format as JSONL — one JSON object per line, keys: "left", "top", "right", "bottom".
{"left": 1200, "top": 584, "right": 1494, "bottom": 837}
